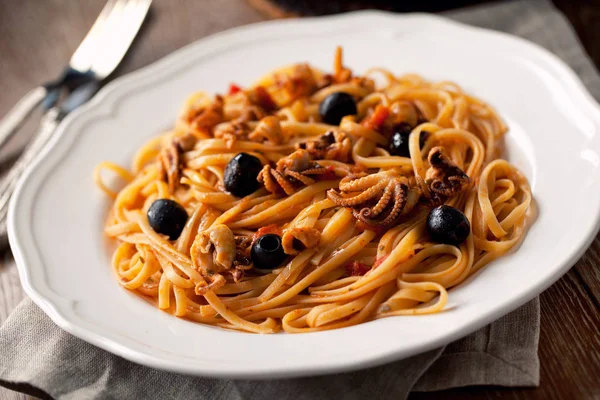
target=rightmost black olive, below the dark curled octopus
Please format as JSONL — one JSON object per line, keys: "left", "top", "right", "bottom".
{"left": 427, "top": 205, "right": 471, "bottom": 245}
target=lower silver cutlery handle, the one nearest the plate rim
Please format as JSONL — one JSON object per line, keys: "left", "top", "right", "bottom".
{"left": 0, "top": 107, "right": 62, "bottom": 250}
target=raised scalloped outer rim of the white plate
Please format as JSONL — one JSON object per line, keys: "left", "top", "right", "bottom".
{"left": 8, "top": 11, "right": 600, "bottom": 379}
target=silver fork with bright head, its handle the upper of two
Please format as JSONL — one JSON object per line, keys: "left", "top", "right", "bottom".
{"left": 0, "top": 0, "right": 152, "bottom": 147}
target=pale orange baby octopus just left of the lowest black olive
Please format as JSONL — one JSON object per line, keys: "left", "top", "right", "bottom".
{"left": 190, "top": 224, "right": 251, "bottom": 295}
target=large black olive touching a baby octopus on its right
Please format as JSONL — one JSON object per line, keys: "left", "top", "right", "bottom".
{"left": 224, "top": 153, "right": 262, "bottom": 197}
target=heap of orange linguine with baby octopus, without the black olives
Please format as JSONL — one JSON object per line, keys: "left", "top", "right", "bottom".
{"left": 95, "top": 49, "right": 532, "bottom": 333}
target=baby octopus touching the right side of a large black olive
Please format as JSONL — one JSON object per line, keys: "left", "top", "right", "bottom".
{"left": 258, "top": 149, "right": 328, "bottom": 196}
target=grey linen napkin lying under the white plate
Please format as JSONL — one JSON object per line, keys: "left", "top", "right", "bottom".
{"left": 0, "top": 0, "right": 600, "bottom": 400}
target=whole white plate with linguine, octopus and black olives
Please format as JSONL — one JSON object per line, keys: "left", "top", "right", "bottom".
{"left": 9, "top": 12, "right": 600, "bottom": 378}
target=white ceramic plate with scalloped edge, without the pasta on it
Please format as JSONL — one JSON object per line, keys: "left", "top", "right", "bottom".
{"left": 9, "top": 12, "right": 600, "bottom": 378}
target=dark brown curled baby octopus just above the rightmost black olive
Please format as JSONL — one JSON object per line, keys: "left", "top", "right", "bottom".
{"left": 425, "top": 147, "right": 470, "bottom": 204}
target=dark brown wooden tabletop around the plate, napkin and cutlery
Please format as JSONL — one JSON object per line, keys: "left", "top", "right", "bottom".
{"left": 0, "top": 0, "right": 600, "bottom": 399}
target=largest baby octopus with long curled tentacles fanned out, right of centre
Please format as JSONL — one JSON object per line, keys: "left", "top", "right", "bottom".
{"left": 327, "top": 171, "right": 409, "bottom": 226}
